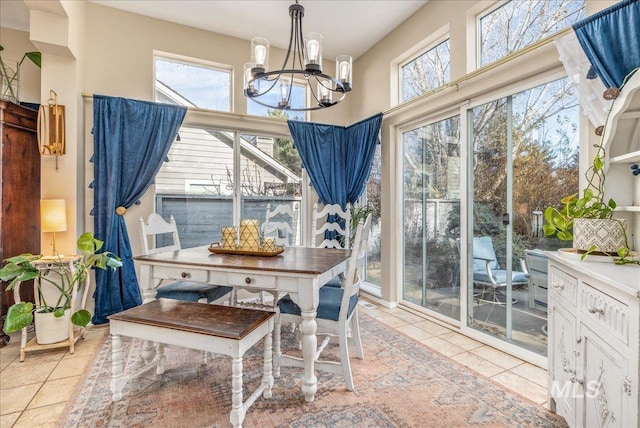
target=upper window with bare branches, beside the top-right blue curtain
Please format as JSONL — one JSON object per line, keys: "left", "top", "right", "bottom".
{"left": 479, "top": 0, "right": 586, "bottom": 67}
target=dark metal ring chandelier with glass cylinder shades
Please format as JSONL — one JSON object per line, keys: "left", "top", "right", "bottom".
{"left": 244, "top": 0, "right": 353, "bottom": 111}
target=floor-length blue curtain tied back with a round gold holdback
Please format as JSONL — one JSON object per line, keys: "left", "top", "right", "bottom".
{"left": 91, "top": 95, "right": 187, "bottom": 324}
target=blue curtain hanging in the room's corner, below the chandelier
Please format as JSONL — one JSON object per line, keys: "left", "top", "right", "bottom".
{"left": 287, "top": 113, "right": 382, "bottom": 208}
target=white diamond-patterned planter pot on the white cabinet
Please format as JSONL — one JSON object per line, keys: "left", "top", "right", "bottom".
{"left": 573, "top": 218, "right": 628, "bottom": 253}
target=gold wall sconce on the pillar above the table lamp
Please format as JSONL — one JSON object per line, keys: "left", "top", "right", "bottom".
{"left": 38, "top": 90, "right": 66, "bottom": 169}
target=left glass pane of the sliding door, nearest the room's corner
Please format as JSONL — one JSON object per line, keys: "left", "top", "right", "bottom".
{"left": 402, "top": 116, "right": 460, "bottom": 319}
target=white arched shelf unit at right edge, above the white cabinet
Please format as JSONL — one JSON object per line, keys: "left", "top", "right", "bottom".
{"left": 602, "top": 71, "right": 640, "bottom": 251}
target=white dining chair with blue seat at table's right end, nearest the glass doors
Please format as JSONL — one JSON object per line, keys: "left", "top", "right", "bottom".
{"left": 274, "top": 214, "right": 371, "bottom": 391}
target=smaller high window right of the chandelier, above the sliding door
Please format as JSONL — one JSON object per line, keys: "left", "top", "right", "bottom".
{"left": 400, "top": 39, "right": 451, "bottom": 102}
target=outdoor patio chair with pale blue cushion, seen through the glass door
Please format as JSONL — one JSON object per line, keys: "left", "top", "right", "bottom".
{"left": 472, "top": 236, "right": 529, "bottom": 305}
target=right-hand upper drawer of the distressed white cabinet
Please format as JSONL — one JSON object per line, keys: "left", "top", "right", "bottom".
{"left": 579, "top": 283, "right": 629, "bottom": 345}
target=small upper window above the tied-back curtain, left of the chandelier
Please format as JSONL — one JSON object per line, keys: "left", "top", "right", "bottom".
{"left": 155, "top": 57, "right": 231, "bottom": 111}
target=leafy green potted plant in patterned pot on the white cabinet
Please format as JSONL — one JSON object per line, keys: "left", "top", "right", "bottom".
{"left": 542, "top": 113, "right": 640, "bottom": 264}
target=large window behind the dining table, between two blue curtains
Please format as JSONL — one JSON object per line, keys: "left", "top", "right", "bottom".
{"left": 155, "top": 125, "right": 306, "bottom": 248}
